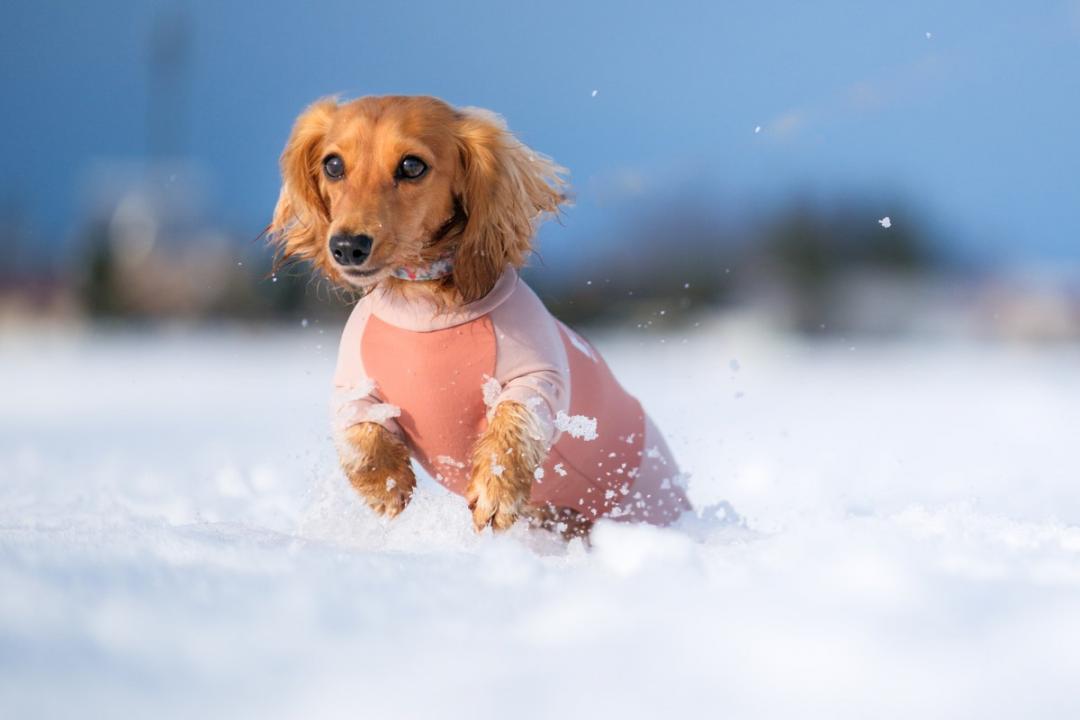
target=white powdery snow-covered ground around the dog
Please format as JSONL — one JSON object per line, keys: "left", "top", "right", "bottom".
{"left": 0, "top": 325, "right": 1080, "bottom": 719}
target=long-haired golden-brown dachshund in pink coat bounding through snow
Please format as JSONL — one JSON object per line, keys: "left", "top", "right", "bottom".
{"left": 269, "top": 96, "right": 690, "bottom": 536}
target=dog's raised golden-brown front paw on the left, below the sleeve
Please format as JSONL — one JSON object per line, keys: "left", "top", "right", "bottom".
{"left": 337, "top": 422, "right": 416, "bottom": 517}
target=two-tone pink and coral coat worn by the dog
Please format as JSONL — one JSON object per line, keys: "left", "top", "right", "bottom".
{"left": 334, "top": 268, "right": 690, "bottom": 525}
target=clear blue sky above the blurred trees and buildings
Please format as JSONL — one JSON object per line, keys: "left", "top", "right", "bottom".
{"left": 0, "top": 0, "right": 1080, "bottom": 263}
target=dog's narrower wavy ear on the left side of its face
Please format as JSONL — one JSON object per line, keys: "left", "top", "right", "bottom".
{"left": 270, "top": 99, "right": 337, "bottom": 264}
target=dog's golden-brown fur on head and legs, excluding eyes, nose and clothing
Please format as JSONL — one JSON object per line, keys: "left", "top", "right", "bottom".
{"left": 270, "top": 96, "right": 589, "bottom": 534}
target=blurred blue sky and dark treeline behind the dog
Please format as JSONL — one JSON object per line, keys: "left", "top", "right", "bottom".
{"left": 0, "top": 0, "right": 1080, "bottom": 342}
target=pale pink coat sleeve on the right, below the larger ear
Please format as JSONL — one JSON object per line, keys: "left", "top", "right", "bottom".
{"left": 485, "top": 281, "right": 570, "bottom": 445}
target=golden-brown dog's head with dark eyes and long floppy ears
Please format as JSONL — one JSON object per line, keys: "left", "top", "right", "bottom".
{"left": 270, "top": 96, "right": 566, "bottom": 302}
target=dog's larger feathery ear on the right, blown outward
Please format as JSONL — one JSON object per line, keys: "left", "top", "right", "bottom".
{"left": 454, "top": 108, "right": 567, "bottom": 302}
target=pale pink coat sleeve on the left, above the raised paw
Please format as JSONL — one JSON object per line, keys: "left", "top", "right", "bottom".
{"left": 330, "top": 300, "right": 402, "bottom": 437}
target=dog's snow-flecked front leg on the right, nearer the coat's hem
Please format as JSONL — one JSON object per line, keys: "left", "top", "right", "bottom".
{"left": 465, "top": 400, "right": 548, "bottom": 532}
